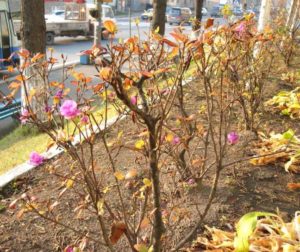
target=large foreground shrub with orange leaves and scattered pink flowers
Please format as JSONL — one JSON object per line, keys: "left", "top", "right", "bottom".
{"left": 1, "top": 16, "right": 284, "bottom": 251}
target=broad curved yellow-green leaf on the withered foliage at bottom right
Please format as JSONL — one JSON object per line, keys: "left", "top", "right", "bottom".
{"left": 234, "top": 212, "right": 276, "bottom": 252}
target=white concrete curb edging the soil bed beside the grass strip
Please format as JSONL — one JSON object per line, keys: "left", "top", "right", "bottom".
{"left": 0, "top": 76, "right": 194, "bottom": 188}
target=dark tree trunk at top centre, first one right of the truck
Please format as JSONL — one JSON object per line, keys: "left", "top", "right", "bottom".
{"left": 152, "top": 0, "right": 167, "bottom": 35}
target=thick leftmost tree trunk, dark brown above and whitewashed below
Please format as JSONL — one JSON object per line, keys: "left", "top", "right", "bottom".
{"left": 21, "top": 0, "right": 47, "bottom": 121}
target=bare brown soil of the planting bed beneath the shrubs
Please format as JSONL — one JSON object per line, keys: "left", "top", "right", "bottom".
{"left": 0, "top": 57, "right": 300, "bottom": 251}
